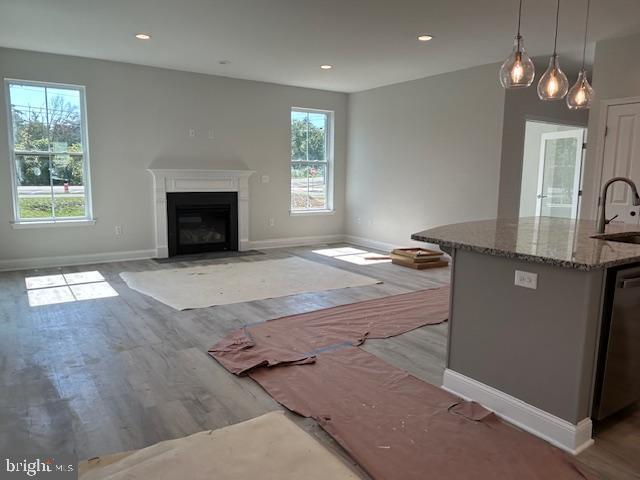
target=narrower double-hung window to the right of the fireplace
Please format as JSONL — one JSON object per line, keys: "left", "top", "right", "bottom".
{"left": 291, "top": 108, "right": 333, "bottom": 213}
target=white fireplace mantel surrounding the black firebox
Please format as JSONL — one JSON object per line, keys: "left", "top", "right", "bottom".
{"left": 148, "top": 166, "right": 254, "bottom": 258}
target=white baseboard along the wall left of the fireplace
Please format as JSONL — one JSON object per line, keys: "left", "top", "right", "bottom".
{"left": 0, "top": 249, "right": 156, "bottom": 272}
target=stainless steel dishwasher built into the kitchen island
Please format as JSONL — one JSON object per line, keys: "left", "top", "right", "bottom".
{"left": 593, "top": 267, "right": 640, "bottom": 420}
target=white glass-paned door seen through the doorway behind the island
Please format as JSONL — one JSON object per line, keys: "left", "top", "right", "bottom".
{"left": 536, "top": 128, "right": 585, "bottom": 218}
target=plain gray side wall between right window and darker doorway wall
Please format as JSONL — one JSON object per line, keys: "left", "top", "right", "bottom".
{"left": 346, "top": 65, "right": 504, "bottom": 248}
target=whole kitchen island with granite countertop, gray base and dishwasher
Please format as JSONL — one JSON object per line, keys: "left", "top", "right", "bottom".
{"left": 411, "top": 217, "right": 640, "bottom": 454}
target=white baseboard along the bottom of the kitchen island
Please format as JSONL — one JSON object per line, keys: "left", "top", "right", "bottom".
{"left": 442, "top": 368, "right": 593, "bottom": 455}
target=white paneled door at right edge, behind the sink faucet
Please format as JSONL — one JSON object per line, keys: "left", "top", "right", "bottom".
{"left": 600, "top": 103, "right": 640, "bottom": 224}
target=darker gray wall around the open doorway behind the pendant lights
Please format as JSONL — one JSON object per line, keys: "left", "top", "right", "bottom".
{"left": 498, "top": 61, "right": 589, "bottom": 218}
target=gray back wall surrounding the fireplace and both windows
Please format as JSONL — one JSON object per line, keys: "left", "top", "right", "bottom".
{"left": 0, "top": 49, "right": 347, "bottom": 261}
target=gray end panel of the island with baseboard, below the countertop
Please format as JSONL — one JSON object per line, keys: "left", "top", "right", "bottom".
{"left": 444, "top": 249, "right": 606, "bottom": 453}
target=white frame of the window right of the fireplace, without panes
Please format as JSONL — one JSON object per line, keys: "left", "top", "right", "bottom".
{"left": 289, "top": 106, "right": 335, "bottom": 217}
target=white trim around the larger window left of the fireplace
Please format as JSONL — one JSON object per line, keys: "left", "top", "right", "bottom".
{"left": 4, "top": 78, "right": 95, "bottom": 228}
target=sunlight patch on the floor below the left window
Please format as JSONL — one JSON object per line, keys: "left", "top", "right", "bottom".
{"left": 24, "top": 270, "right": 118, "bottom": 307}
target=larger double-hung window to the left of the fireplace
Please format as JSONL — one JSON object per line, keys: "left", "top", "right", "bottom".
{"left": 5, "top": 80, "right": 92, "bottom": 223}
